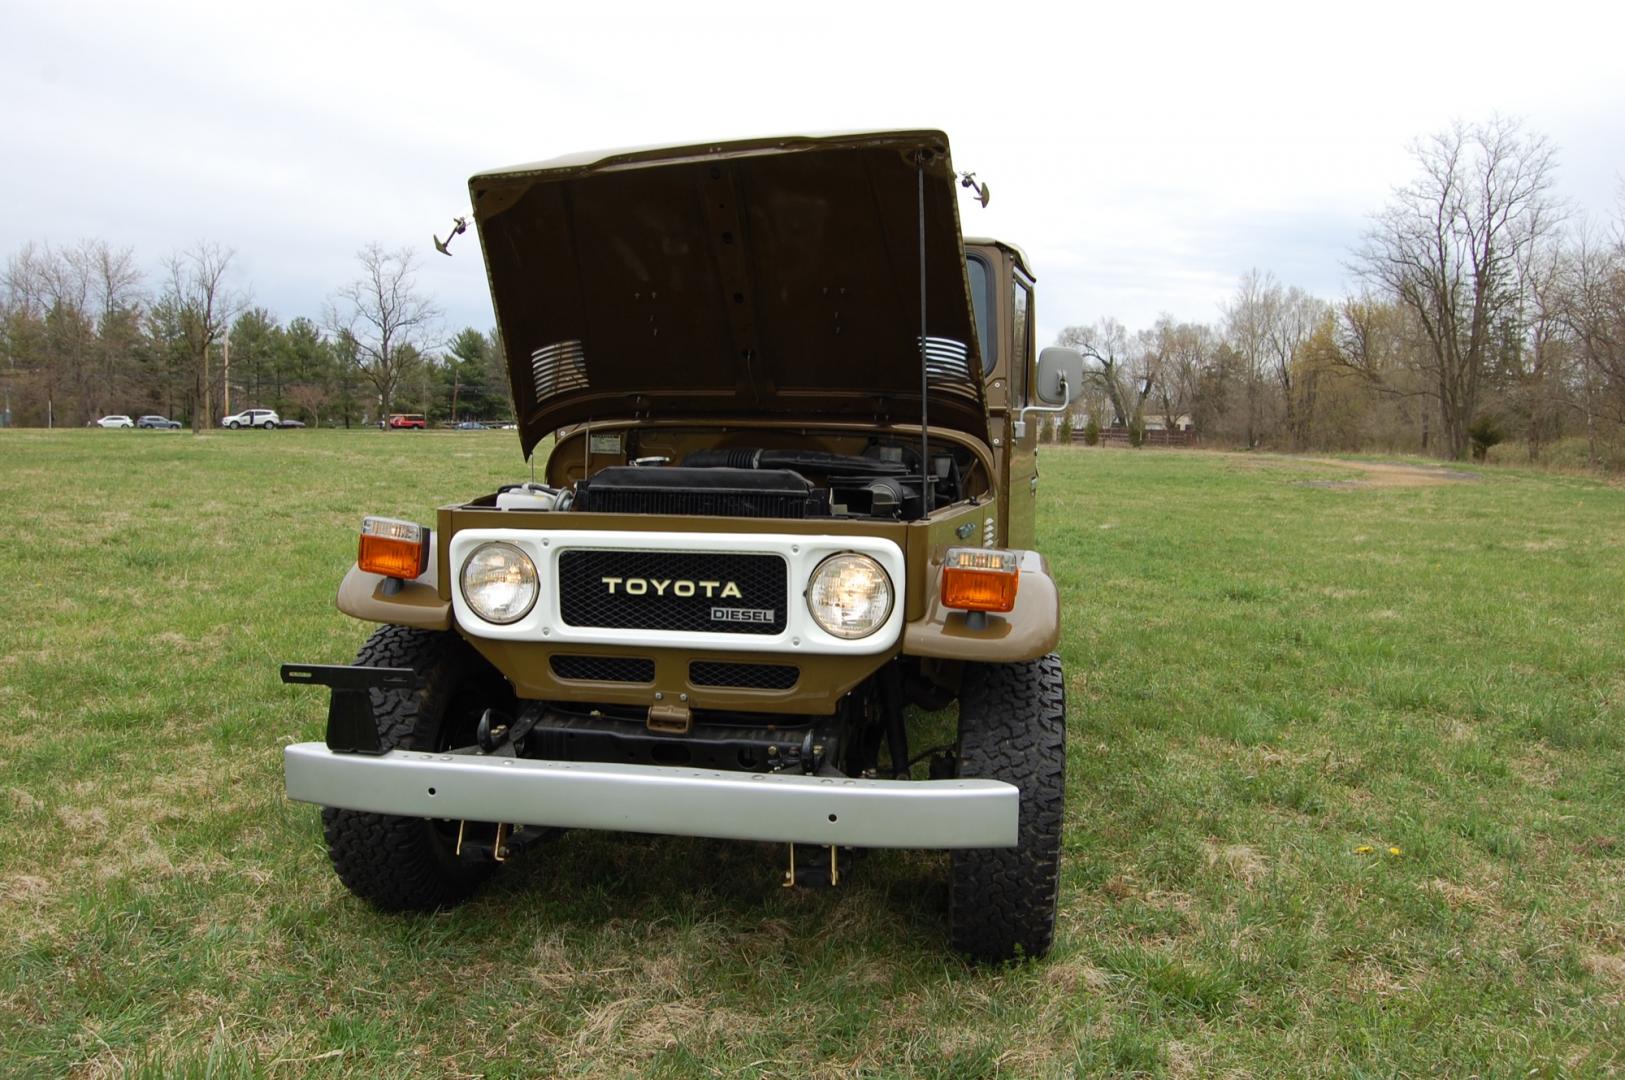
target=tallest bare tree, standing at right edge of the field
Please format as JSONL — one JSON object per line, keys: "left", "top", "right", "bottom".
{"left": 1355, "top": 119, "right": 1557, "bottom": 460}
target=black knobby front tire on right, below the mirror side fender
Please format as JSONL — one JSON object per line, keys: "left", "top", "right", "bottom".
{"left": 947, "top": 653, "right": 1066, "bottom": 963}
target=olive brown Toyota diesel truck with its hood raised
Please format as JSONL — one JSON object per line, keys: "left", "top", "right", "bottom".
{"left": 283, "top": 132, "right": 1082, "bottom": 960}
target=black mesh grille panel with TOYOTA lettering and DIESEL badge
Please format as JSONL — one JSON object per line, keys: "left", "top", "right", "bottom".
{"left": 559, "top": 549, "right": 788, "bottom": 633}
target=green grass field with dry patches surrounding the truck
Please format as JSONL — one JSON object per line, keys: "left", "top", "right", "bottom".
{"left": 0, "top": 430, "right": 1625, "bottom": 1078}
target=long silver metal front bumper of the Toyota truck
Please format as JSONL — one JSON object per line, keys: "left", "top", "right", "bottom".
{"left": 283, "top": 742, "right": 1019, "bottom": 848}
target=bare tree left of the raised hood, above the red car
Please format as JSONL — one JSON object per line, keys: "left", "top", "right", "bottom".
{"left": 327, "top": 244, "right": 440, "bottom": 416}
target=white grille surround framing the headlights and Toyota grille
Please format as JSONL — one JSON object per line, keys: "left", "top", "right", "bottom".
{"left": 449, "top": 529, "right": 905, "bottom": 656}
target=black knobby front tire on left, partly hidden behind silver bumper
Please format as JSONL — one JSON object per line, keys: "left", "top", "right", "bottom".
{"left": 322, "top": 627, "right": 514, "bottom": 911}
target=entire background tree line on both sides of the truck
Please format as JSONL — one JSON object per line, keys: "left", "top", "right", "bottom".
{"left": 12, "top": 119, "right": 1625, "bottom": 468}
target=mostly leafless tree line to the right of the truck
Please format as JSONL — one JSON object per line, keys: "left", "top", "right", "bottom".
{"left": 1058, "top": 119, "right": 1625, "bottom": 468}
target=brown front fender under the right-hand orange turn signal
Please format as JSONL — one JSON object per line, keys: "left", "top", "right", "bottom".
{"left": 904, "top": 551, "right": 1061, "bottom": 664}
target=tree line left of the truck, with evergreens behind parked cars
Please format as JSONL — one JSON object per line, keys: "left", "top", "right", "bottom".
{"left": 0, "top": 240, "right": 514, "bottom": 430}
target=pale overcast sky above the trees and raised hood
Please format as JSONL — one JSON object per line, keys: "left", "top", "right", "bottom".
{"left": 0, "top": 0, "right": 1625, "bottom": 343}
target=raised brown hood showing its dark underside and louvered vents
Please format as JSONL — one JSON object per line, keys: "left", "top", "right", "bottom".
{"left": 468, "top": 132, "right": 988, "bottom": 455}
